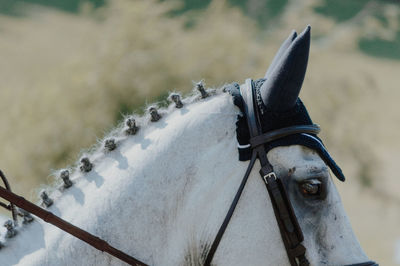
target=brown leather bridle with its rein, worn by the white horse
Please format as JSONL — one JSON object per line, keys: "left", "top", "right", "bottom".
{"left": 0, "top": 79, "right": 378, "bottom": 266}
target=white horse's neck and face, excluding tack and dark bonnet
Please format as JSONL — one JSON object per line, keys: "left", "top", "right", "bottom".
{"left": 0, "top": 26, "right": 376, "bottom": 266}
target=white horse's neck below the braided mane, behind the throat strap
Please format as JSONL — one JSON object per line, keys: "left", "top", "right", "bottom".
{"left": 0, "top": 92, "right": 284, "bottom": 265}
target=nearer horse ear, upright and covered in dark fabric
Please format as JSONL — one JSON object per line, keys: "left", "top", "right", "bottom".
{"left": 260, "top": 26, "right": 311, "bottom": 112}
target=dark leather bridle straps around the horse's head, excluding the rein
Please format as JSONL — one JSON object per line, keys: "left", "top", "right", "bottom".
{"left": 205, "top": 79, "right": 320, "bottom": 266}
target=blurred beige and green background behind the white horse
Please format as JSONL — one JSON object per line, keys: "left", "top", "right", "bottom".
{"left": 0, "top": 0, "right": 400, "bottom": 265}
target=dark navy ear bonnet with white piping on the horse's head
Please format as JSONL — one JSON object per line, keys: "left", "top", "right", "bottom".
{"left": 228, "top": 26, "right": 345, "bottom": 181}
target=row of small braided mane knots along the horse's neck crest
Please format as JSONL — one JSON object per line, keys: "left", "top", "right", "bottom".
{"left": 37, "top": 81, "right": 226, "bottom": 214}
